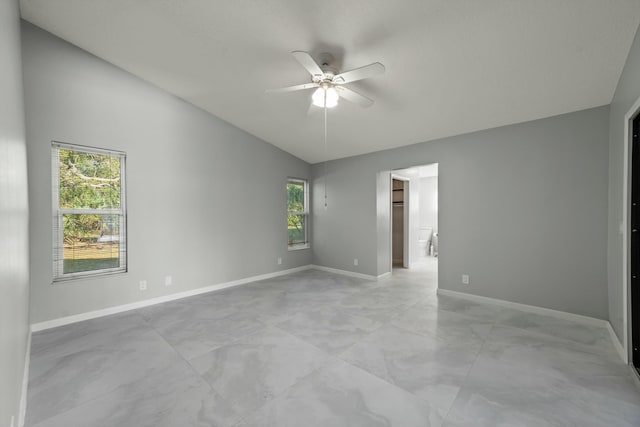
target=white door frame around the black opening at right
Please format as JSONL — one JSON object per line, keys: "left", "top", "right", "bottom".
{"left": 620, "top": 93, "right": 640, "bottom": 363}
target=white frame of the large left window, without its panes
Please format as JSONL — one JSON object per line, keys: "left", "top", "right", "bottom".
{"left": 51, "top": 141, "right": 127, "bottom": 283}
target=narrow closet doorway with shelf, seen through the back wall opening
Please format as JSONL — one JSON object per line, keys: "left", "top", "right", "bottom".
{"left": 391, "top": 175, "right": 409, "bottom": 268}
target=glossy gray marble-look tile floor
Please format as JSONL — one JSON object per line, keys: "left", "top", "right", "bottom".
{"left": 27, "top": 259, "right": 640, "bottom": 427}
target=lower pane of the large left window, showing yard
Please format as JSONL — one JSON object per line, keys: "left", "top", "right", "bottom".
{"left": 62, "top": 214, "right": 124, "bottom": 274}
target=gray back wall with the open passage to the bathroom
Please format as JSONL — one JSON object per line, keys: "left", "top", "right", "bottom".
{"left": 313, "top": 107, "right": 609, "bottom": 319}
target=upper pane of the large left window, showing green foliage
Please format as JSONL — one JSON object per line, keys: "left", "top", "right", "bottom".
{"left": 59, "top": 149, "right": 120, "bottom": 209}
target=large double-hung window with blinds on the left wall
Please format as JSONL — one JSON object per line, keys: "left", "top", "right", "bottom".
{"left": 52, "top": 142, "right": 127, "bottom": 281}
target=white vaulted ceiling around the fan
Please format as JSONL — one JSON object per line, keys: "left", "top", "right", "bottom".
{"left": 21, "top": 0, "right": 640, "bottom": 163}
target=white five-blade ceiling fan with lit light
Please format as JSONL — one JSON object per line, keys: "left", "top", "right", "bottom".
{"left": 267, "top": 50, "right": 385, "bottom": 108}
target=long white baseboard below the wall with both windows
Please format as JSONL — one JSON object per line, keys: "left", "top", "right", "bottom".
{"left": 31, "top": 265, "right": 314, "bottom": 332}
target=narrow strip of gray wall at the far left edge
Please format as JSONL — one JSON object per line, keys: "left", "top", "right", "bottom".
{"left": 0, "top": 0, "right": 29, "bottom": 426}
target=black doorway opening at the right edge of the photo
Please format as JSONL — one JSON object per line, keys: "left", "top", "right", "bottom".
{"left": 629, "top": 113, "right": 640, "bottom": 372}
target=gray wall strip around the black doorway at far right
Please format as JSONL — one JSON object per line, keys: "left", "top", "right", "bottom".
{"left": 608, "top": 23, "right": 640, "bottom": 341}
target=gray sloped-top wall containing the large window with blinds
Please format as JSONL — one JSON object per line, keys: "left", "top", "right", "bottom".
{"left": 22, "top": 22, "right": 311, "bottom": 323}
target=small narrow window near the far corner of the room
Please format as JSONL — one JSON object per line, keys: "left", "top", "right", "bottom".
{"left": 287, "top": 178, "right": 309, "bottom": 249}
